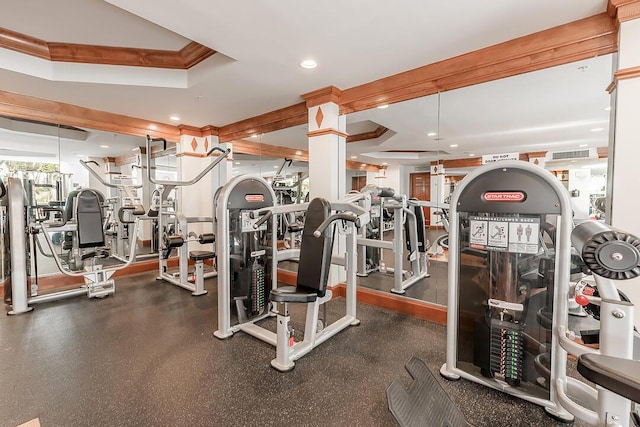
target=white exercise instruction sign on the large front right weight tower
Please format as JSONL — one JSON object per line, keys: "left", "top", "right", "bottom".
{"left": 469, "top": 216, "right": 540, "bottom": 254}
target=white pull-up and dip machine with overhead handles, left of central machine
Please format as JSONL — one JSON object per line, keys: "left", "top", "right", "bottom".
{"left": 146, "top": 135, "right": 231, "bottom": 296}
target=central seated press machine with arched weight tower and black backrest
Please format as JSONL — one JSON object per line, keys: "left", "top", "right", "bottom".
{"left": 214, "top": 175, "right": 369, "bottom": 372}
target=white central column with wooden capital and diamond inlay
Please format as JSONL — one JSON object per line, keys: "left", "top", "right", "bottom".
{"left": 302, "top": 86, "right": 347, "bottom": 286}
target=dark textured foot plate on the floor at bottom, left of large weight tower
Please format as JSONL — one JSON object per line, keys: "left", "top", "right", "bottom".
{"left": 387, "top": 357, "right": 471, "bottom": 427}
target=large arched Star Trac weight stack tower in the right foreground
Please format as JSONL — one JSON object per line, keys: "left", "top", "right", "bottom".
{"left": 440, "top": 161, "right": 573, "bottom": 421}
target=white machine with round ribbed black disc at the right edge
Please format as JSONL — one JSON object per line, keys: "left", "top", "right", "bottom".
{"left": 552, "top": 221, "right": 640, "bottom": 427}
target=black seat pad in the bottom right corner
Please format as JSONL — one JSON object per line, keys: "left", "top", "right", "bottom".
{"left": 578, "top": 353, "right": 640, "bottom": 402}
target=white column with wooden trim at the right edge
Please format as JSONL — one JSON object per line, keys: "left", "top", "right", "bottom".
{"left": 607, "top": 0, "right": 640, "bottom": 328}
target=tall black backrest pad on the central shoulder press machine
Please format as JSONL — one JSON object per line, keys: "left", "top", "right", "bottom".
{"left": 296, "top": 198, "right": 334, "bottom": 297}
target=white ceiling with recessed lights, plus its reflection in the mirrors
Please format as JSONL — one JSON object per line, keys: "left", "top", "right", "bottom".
{"left": 0, "top": 0, "right": 612, "bottom": 164}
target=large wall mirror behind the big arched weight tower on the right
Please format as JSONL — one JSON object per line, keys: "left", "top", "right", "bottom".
{"left": 347, "top": 55, "right": 613, "bottom": 305}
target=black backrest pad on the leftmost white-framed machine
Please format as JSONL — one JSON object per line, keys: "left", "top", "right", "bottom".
{"left": 76, "top": 190, "right": 104, "bottom": 248}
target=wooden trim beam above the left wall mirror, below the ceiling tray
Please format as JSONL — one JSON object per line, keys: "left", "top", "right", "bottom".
{"left": 0, "top": 91, "right": 180, "bottom": 141}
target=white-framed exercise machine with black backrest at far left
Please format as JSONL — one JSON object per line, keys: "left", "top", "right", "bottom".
{"left": 5, "top": 178, "right": 138, "bottom": 314}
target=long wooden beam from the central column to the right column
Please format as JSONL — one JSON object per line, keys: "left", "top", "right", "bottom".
{"left": 340, "top": 13, "right": 618, "bottom": 114}
